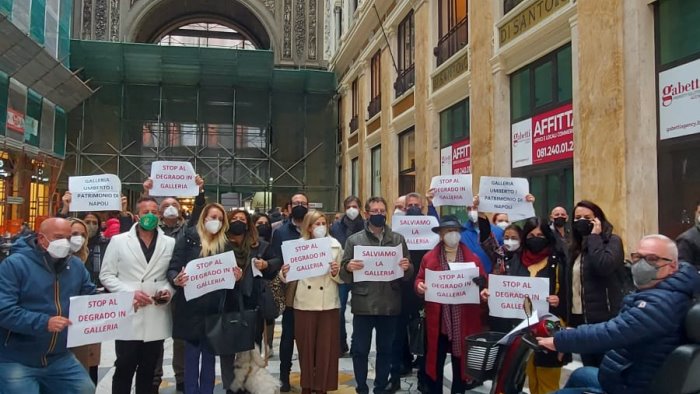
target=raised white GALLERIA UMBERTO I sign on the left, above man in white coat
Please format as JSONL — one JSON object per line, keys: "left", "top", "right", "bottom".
{"left": 68, "top": 174, "right": 122, "bottom": 212}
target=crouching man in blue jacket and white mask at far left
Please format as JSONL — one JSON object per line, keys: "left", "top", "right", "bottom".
{"left": 0, "top": 218, "right": 95, "bottom": 394}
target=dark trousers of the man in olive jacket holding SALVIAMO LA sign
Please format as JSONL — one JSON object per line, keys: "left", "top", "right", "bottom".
{"left": 352, "top": 315, "right": 397, "bottom": 394}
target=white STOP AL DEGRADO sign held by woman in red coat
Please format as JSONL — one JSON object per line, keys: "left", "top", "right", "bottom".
{"left": 425, "top": 268, "right": 480, "bottom": 305}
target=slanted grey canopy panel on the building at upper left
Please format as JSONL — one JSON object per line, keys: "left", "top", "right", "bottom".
{"left": 0, "top": 14, "right": 93, "bottom": 111}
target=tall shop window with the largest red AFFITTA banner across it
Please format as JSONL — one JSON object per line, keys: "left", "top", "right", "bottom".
{"left": 510, "top": 44, "right": 574, "bottom": 212}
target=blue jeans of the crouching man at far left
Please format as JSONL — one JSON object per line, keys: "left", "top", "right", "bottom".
{"left": 0, "top": 352, "right": 95, "bottom": 394}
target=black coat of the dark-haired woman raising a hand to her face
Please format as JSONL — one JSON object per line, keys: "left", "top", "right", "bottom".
{"left": 566, "top": 234, "right": 627, "bottom": 323}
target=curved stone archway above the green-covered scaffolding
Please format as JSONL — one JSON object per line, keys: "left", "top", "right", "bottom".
{"left": 122, "top": 0, "right": 280, "bottom": 54}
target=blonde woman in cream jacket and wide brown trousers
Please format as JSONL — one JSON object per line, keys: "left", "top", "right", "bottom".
{"left": 280, "top": 211, "right": 343, "bottom": 394}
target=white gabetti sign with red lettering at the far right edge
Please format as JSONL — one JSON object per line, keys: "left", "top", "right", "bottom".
{"left": 659, "top": 59, "right": 700, "bottom": 140}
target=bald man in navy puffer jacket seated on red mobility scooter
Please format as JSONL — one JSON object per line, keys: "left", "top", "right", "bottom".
{"left": 538, "top": 234, "right": 700, "bottom": 394}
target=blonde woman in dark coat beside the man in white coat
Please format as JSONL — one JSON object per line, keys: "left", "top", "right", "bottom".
{"left": 168, "top": 203, "right": 242, "bottom": 394}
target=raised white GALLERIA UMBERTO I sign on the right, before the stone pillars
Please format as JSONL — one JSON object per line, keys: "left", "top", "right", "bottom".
{"left": 479, "top": 176, "right": 535, "bottom": 220}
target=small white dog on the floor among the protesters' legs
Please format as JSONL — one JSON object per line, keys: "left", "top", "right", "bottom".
{"left": 231, "top": 349, "right": 282, "bottom": 394}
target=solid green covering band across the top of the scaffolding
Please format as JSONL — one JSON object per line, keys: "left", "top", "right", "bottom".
{"left": 71, "top": 40, "right": 336, "bottom": 94}
